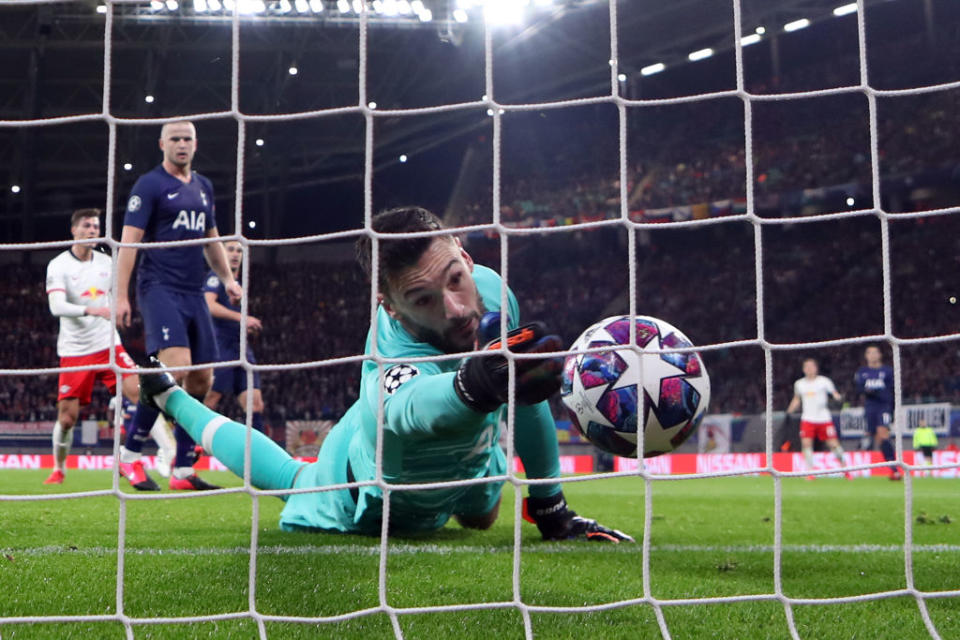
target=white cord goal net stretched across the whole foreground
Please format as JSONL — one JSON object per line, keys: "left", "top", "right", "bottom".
{"left": 0, "top": 0, "right": 960, "bottom": 639}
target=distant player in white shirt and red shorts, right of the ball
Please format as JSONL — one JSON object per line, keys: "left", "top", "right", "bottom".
{"left": 787, "top": 358, "right": 852, "bottom": 480}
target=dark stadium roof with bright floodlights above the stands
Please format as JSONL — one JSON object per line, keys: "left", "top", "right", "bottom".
{"left": 0, "top": 0, "right": 932, "bottom": 240}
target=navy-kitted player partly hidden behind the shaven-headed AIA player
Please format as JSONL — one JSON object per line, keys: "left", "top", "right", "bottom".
{"left": 203, "top": 240, "right": 264, "bottom": 431}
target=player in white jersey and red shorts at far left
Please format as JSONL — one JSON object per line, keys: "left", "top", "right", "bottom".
{"left": 44, "top": 209, "right": 139, "bottom": 484}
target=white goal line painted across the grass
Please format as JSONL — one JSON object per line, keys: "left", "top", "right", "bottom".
{"left": 7, "top": 543, "right": 960, "bottom": 560}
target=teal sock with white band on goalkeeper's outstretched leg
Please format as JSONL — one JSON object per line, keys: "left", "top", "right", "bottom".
{"left": 157, "top": 388, "right": 304, "bottom": 489}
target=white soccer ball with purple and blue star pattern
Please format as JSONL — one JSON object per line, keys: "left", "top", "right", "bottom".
{"left": 560, "top": 316, "right": 710, "bottom": 458}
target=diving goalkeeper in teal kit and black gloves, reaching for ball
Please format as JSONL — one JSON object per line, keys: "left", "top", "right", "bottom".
{"left": 135, "top": 207, "right": 633, "bottom": 542}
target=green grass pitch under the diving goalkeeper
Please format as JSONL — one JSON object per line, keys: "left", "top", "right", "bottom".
{"left": 0, "top": 470, "right": 960, "bottom": 640}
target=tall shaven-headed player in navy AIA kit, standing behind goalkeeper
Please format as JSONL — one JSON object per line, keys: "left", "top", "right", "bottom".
{"left": 117, "top": 122, "right": 242, "bottom": 490}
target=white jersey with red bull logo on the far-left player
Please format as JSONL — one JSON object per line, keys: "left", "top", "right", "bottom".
{"left": 47, "top": 250, "right": 120, "bottom": 357}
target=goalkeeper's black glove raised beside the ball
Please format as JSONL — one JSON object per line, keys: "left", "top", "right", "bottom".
{"left": 453, "top": 322, "right": 563, "bottom": 413}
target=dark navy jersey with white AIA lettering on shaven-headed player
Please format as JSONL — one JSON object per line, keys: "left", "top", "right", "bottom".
{"left": 123, "top": 165, "right": 217, "bottom": 292}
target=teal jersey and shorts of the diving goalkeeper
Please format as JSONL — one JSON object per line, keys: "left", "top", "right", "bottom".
{"left": 281, "top": 265, "right": 559, "bottom": 533}
